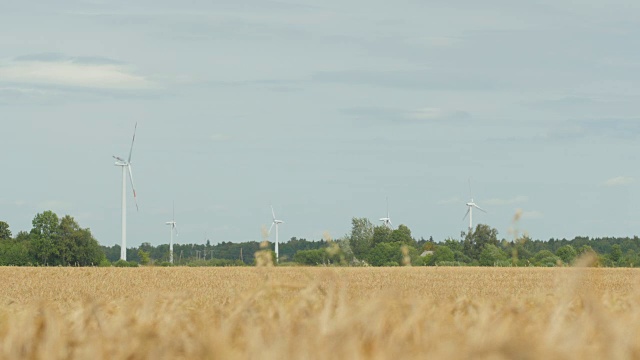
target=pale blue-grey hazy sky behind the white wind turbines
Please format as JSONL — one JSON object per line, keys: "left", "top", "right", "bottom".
{"left": 0, "top": 0, "right": 640, "bottom": 246}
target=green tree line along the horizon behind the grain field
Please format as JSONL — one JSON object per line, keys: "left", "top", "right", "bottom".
{"left": 0, "top": 211, "right": 640, "bottom": 267}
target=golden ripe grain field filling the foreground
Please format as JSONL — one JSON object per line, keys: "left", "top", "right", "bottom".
{"left": 0, "top": 267, "right": 640, "bottom": 359}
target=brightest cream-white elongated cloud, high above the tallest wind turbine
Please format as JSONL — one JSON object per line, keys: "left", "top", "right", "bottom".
{"left": 0, "top": 53, "right": 156, "bottom": 90}
